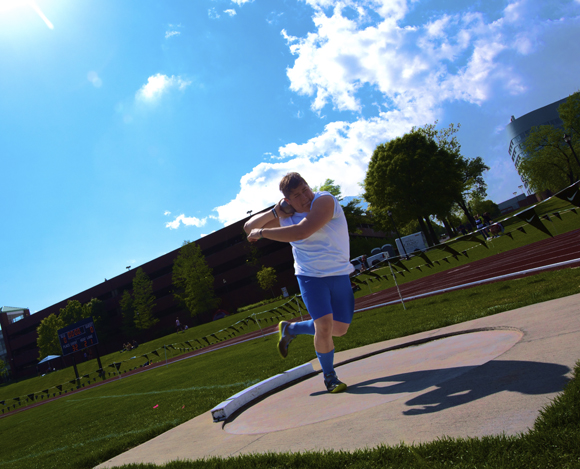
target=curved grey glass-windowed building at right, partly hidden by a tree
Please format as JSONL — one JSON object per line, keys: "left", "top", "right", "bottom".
{"left": 506, "top": 98, "right": 567, "bottom": 189}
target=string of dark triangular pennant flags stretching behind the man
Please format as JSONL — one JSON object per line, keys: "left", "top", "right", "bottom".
{"left": 0, "top": 181, "right": 580, "bottom": 413}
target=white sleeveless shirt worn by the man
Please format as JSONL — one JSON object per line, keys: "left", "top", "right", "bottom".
{"left": 280, "top": 191, "right": 354, "bottom": 277}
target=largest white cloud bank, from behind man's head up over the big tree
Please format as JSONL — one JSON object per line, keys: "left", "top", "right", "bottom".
{"left": 214, "top": 0, "right": 576, "bottom": 224}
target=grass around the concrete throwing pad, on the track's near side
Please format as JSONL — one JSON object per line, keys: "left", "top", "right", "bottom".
{"left": 0, "top": 269, "right": 580, "bottom": 469}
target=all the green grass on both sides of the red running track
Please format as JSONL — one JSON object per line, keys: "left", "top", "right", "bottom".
{"left": 0, "top": 195, "right": 580, "bottom": 469}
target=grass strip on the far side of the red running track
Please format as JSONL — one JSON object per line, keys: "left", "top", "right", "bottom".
{"left": 0, "top": 198, "right": 580, "bottom": 408}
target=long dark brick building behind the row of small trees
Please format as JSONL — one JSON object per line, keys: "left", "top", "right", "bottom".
{"left": 0, "top": 207, "right": 298, "bottom": 377}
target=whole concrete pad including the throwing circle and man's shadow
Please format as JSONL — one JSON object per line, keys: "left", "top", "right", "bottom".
{"left": 97, "top": 294, "right": 580, "bottom": 468}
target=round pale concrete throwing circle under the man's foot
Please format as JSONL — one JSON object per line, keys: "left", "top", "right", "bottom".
{"left": 224, "top": 330, "right": 523, "bottom": 434}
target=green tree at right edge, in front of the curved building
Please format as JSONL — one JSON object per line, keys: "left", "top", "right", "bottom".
{"left": 518, "top": 91, "right": 580, "bottom": 191}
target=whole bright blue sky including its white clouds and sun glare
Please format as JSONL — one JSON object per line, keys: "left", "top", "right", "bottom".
{"left": 0, "top": 0, "right": 580, "bottom": 313}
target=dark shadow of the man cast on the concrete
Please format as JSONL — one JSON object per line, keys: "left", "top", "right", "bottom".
{"left": 312, "top": 360, "right": 571, "bottom": 415}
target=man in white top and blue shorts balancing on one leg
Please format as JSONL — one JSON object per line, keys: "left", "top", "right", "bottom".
{"left": 244, "top": 173, "right": 354, "bottom": 393}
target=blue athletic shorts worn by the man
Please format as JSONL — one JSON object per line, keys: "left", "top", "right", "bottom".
{"left": 296, "top": 275, "right": 354, "bottom": 324}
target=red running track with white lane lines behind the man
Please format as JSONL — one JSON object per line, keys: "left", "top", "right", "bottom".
{"left": 0, "top": 230, "right": 580, "bottom": 418}
